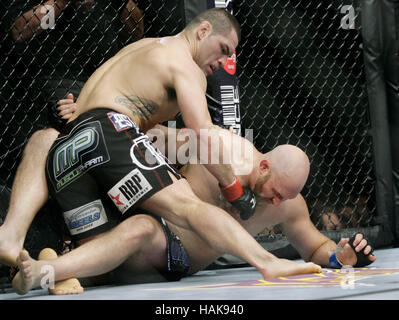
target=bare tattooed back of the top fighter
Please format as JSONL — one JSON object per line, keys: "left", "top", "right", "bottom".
{"left": 69, "top": 36, "right": 206, "bottom": 132}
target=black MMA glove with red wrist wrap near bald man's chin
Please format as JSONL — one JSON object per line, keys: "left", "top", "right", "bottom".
{"left": 219, "top": 177, "right": 256, "bottom": 220}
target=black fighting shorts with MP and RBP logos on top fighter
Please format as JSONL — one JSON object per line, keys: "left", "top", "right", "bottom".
{"left": 46, "top": 109, "right": 181, "bottom": 240}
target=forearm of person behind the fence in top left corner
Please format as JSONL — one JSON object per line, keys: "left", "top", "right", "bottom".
{"left": 12, "top": 0, "right": 67, "bottom": 42}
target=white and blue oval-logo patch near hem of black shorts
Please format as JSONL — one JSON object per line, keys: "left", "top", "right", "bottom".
{"left": 64, "top": 200, "right": 108, "bottom": 235}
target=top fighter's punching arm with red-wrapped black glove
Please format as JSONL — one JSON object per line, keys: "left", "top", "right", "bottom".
{"left": 171, "top": 60, "right": 256, "bottom": 219}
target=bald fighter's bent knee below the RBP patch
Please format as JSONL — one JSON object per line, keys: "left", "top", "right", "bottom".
{"left": 121, "top": 214, "right": 158, "bottom": 244}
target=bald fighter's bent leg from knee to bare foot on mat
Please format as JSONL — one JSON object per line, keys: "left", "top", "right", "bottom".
{"left": 13, "top": 215, "right": 167, "bottom": 294}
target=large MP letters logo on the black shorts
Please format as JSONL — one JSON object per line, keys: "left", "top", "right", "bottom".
{"left": 53, "top": 128, "right": 98, "bottom": 177}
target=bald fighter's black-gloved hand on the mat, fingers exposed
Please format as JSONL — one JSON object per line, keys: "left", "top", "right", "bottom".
{"left": 336, "top": 233, "right": 377, "bottom": 267}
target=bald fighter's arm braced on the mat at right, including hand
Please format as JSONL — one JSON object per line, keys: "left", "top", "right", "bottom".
{"left": 282, "top": 195, "right": 376, "bottom": 267}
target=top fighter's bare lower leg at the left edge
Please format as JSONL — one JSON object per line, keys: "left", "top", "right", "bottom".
{"left": 0, "top": 129, "right": 58, "bottom": 266}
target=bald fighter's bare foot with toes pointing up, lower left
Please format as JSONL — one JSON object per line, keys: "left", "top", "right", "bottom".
{"left": 12, "top": 250, "right": 40, "bottom": 295}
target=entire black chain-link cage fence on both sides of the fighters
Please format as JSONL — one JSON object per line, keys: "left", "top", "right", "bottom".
{"left": 0, "top": 0, "right": 394, "bottom": 270}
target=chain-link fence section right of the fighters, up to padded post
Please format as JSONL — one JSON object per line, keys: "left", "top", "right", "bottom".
{"left": 235, "top": 0, "right": 384, "bottom": 258}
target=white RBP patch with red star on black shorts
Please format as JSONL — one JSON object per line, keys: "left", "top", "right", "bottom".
{"left": 108, "top": 169, "right": 152, "bottom": 214}
